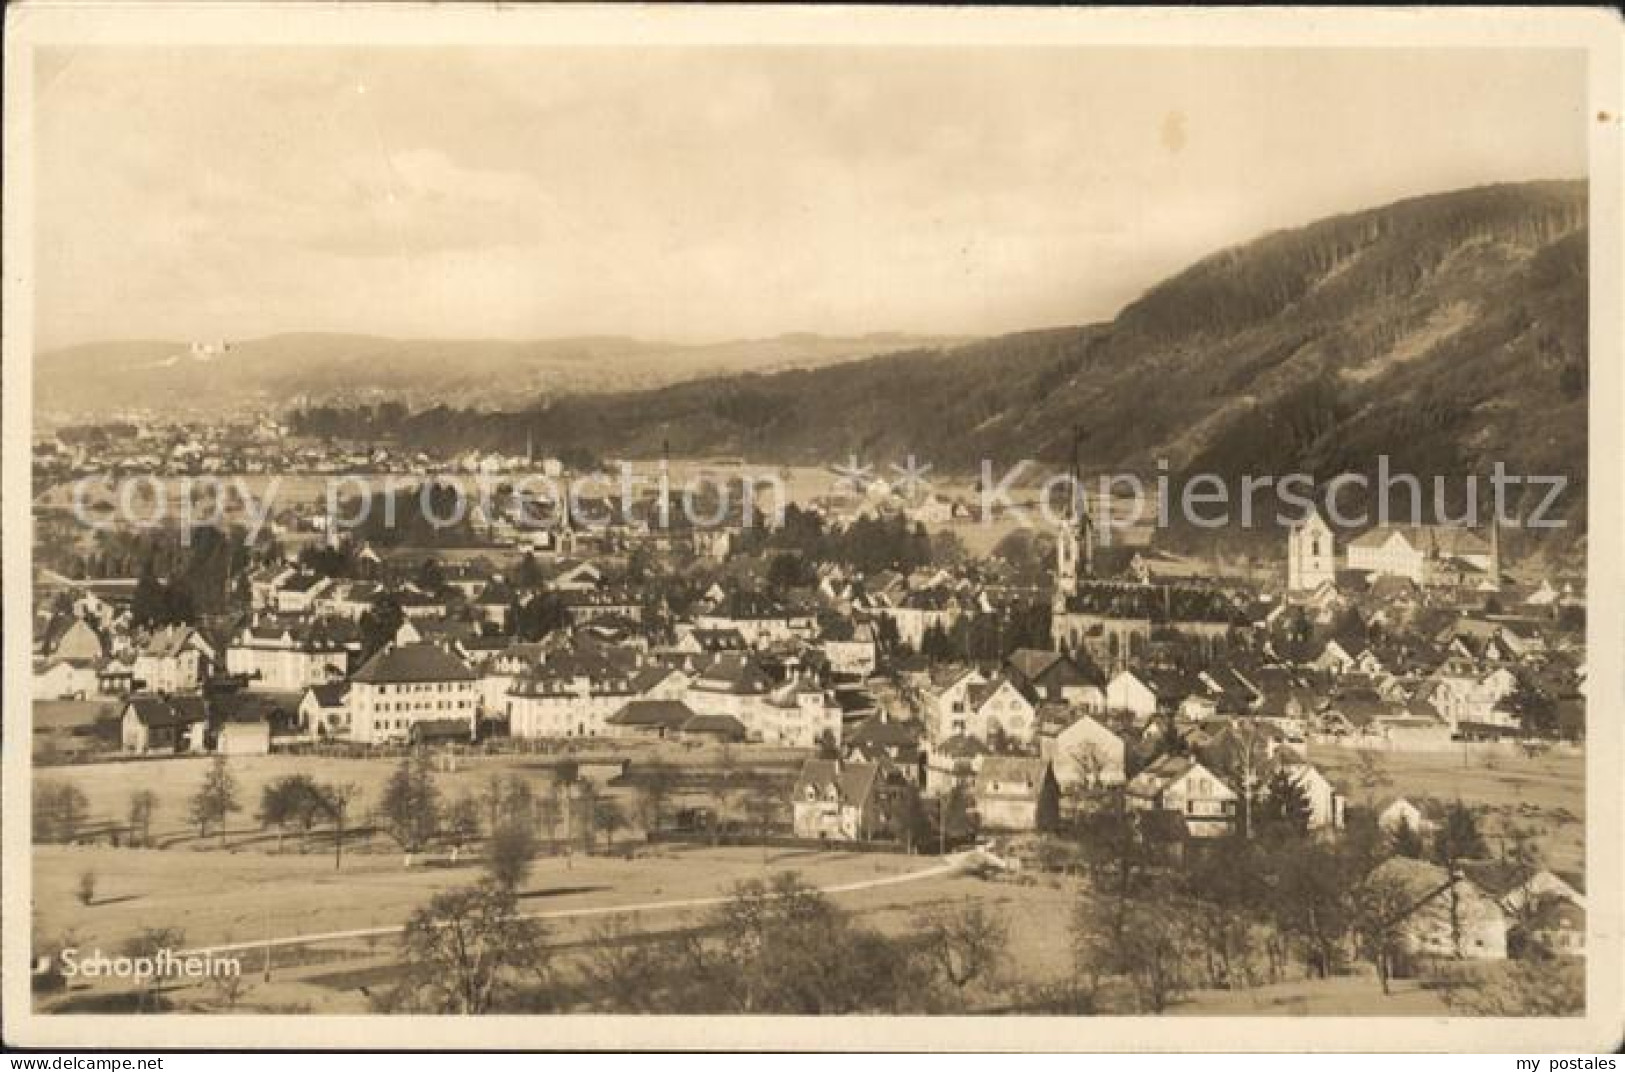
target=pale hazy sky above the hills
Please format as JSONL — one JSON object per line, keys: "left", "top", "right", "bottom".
{"left": 34, "top": 47, "right": 1588, "bottom": 349}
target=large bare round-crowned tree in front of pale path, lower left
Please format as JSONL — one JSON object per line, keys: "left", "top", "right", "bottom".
{"left": 392, "top": 882, "right": 548, "bottom": 1015}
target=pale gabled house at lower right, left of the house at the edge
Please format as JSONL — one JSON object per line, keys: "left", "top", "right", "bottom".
{"left": 1367, "top": 856, "right": 1506, "bottom": 960}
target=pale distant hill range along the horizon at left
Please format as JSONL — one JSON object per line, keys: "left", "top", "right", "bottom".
{"left": 34, "top": 333, "right": 964, "bottom": 416}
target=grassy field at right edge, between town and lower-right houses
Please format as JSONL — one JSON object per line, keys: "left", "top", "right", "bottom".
{"left": 1310, "top": 746, "right": 1586, "bottom": 872}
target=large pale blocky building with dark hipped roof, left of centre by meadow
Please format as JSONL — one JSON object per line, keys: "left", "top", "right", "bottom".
{"left": 349, "top": 643, "right": 479, "bottom": 744}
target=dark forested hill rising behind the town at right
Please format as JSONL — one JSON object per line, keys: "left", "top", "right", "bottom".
{"left": 390, "top": 182, "right": 1588, "bottom": 536}
